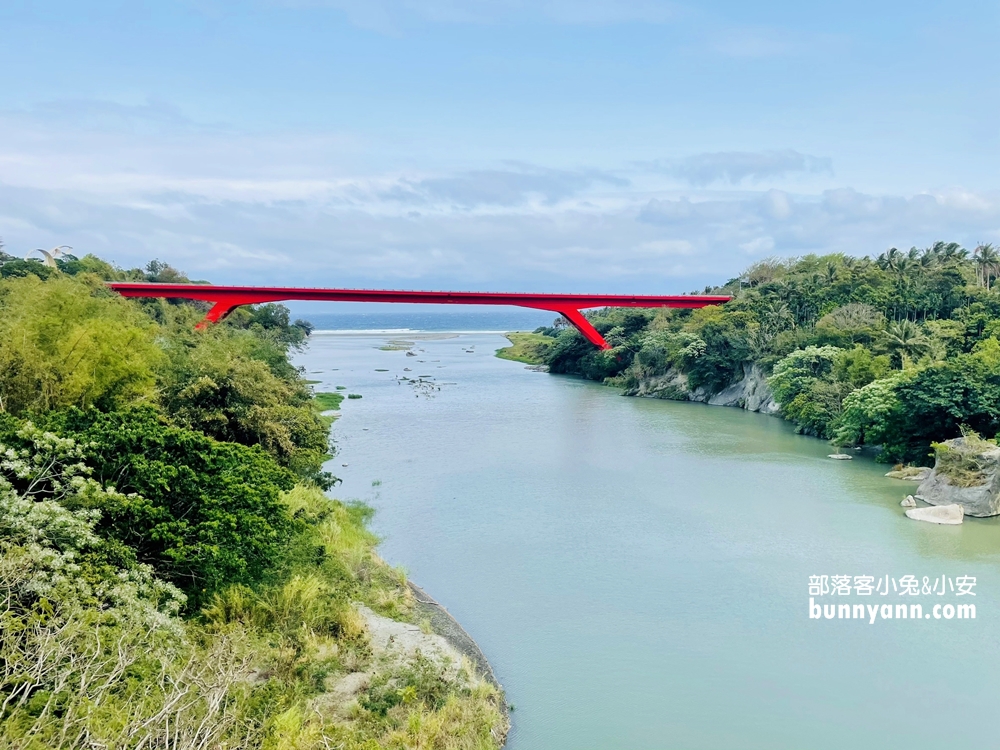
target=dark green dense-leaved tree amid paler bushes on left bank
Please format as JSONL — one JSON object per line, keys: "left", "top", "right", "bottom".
{"left": 22, "top": 407, "right": 295, "bottom": 605}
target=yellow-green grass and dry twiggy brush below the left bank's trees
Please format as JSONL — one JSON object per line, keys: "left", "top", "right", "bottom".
{"left": 0, "top": 485, "right": 507, "bottom": 750}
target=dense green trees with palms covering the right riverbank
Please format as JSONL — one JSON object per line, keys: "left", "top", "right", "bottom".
{"left": 538, "top": 243, "right": 1000, "bottom": 463}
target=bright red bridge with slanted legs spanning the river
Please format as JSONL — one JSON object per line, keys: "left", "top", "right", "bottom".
{"left": 108, "top": 281, "right": 731, "bottom": 349}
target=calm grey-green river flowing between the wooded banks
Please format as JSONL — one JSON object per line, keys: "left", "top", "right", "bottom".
{"left": 298, "top": 333, "right": 1000, "bottom": 750}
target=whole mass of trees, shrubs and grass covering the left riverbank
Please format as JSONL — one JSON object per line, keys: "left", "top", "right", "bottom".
{"left": 0, "top": 253, "right": 500, "bottom": 750}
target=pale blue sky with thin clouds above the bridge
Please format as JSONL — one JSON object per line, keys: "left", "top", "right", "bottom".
{"left": 0, "top": 0, "right": 1000, "bottom": 293}
